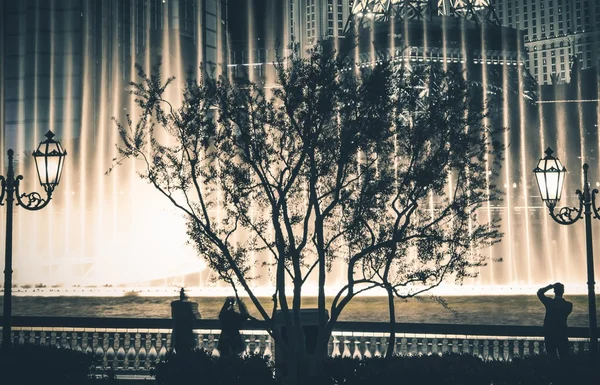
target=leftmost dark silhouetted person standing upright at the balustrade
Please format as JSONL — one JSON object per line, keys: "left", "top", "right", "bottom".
{"left": 171, "top": 287, "right": 202, "bottom": 353}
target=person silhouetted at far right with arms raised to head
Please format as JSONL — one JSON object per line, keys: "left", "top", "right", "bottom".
{"left": 537, "top": 282, "right": 573, "bottom": 359}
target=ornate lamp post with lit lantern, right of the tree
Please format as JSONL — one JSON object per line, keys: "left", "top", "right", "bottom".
{"left": 533, "top": 147, "right": 600, "bottom": 358}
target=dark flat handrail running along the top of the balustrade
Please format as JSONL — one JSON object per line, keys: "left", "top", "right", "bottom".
{"left": 0, "top": 316, "right": 589, "bottom": 338}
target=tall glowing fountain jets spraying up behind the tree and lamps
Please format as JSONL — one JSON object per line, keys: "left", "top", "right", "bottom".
{"left": 0, "top": 1, "right": 600, "bottom": 292}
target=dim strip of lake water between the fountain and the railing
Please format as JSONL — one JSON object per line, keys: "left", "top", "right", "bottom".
{"left": 0, "top": 295, "right": 600, "bottom": 327}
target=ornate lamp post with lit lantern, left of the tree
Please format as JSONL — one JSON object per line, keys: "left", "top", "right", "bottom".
{"left": 0, "top": 131, "right": 67, "bottom": 348}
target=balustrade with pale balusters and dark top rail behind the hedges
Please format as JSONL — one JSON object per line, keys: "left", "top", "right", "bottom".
{"left": 0, "top": 317, "right": 589, "bottom": 374}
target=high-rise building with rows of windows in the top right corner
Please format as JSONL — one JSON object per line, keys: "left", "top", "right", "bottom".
{"left": 492, "top": 0, "right": 600, "bottom": 84}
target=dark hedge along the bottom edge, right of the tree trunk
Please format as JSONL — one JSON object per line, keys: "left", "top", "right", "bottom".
{"left": 321, "top": 354, "right": 600, "bottom": 385}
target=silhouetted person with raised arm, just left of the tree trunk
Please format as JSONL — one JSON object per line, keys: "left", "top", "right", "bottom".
{"left": 218, "top": 297, "right": 250, "bottom": 357}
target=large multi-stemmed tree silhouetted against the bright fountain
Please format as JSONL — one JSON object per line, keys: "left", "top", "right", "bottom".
{"left": 115, "top": 49, "right": 501, "bottom": 384}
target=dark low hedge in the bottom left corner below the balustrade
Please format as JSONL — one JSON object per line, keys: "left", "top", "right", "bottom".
{"left": 0, "top": 344, "right": 116, "bottom": 385}
